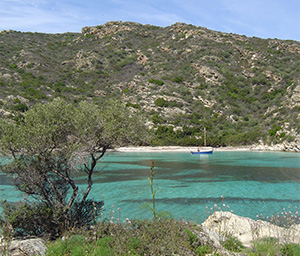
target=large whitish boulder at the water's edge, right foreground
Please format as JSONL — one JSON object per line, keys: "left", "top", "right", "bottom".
{"left": 198, "top": 212, "right": 300, "bottom": 248}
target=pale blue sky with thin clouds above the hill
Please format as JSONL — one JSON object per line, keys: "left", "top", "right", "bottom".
{"left": 0, "top": 0, "right": 300, "bottom": 41}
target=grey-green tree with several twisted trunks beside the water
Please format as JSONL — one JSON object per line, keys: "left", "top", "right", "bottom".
{"left": 0, "top": 99, "right": 147, "bottom": 235}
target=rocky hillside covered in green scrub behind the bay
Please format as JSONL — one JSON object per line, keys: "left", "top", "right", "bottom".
{"left": 0, "top": 22, "right": 300, "bottom": 149}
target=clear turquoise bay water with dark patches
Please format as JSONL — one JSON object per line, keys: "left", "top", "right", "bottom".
{"left": 0, "top": 152, "right": 300, "bottom": 222}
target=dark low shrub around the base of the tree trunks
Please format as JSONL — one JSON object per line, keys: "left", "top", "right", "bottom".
{"left": 2, "top": 200, "right": 103, "bottom": 238}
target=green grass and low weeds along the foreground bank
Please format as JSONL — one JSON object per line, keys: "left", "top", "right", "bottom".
{"left": 46, "top": 219, "right": 300, "bottom": 256}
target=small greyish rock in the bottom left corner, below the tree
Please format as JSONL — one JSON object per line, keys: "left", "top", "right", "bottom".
{"left": 0, "top": 238, "right": 47, "bottom": 256}
